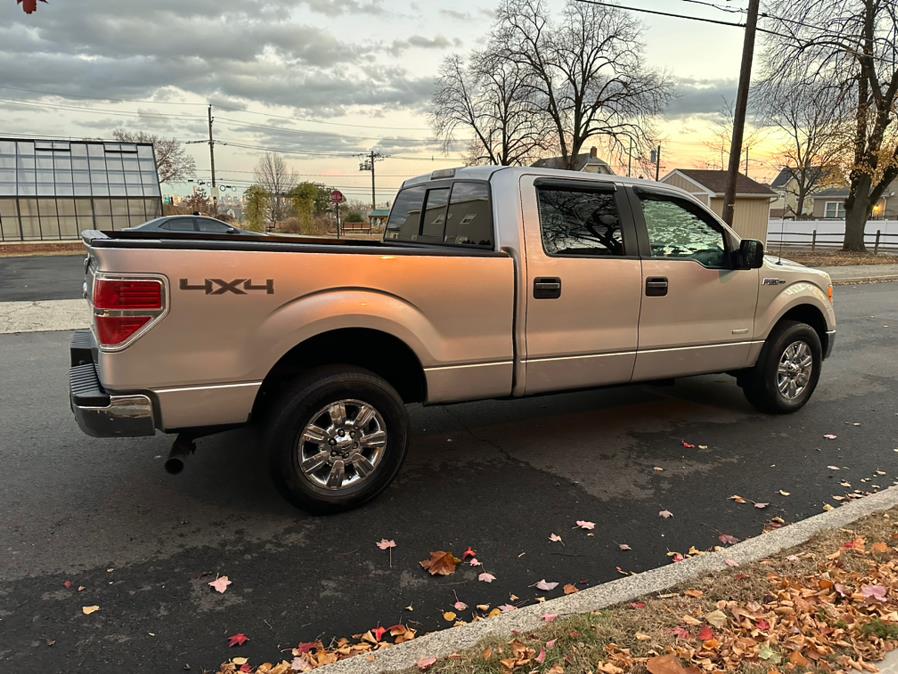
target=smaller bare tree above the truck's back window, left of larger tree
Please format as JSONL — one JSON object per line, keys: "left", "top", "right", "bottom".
{"left": 431, "top": 49, "right": 550, "bottom": 166}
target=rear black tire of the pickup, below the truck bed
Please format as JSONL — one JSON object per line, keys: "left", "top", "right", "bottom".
{"left": 265, "top": 365, "right": 408, "bottom": 514}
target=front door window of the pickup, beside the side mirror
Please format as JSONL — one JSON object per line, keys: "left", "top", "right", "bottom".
{"left": 642, "top": 196, "right": 729, "bottom": 267}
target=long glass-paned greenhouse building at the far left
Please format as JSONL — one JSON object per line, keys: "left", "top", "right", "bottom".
{"left": 0, "top": 138, "right": 162, "bottom": 241}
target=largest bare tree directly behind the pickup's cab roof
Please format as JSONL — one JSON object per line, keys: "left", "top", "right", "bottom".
{"left": 494, "top": 0, "right": 669, "bottom": 168}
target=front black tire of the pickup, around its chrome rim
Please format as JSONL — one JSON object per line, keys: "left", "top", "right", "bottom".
{"left": 739, "top": 321, "right": 823, "bottom": 414}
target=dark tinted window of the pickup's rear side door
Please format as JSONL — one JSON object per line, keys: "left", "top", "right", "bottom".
{"left": 536, "top": 187, "right": 624, "bottom": 257}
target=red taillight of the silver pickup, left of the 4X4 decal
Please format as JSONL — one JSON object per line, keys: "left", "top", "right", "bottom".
{"left": 92, "top": 276, "right": 165, "bottom": 348}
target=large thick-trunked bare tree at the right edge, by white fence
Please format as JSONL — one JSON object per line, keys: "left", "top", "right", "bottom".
{"left": 765, "top": 0, "right": 898, "bottom": 251}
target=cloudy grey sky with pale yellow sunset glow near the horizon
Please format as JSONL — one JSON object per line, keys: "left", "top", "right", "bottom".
{"left": 0, "top": 0, "right": 775, "bottom": 201}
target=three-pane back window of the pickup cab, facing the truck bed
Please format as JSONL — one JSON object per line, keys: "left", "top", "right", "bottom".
{"left": 384, "top": 181, "right": 493, "bottom": 248}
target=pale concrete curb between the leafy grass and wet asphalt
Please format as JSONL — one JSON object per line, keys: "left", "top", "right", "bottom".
{"left": 322, "top": 486, "right": 898, "bottom": 674}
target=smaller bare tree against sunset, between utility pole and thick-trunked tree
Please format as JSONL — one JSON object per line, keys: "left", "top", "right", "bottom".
{"left": 756, "top": 80, "right": 847, "bottom": 217}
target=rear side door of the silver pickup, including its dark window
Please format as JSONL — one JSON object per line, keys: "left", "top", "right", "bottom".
{"left": 519, "top": 176, "right": 642, "bottom": 393}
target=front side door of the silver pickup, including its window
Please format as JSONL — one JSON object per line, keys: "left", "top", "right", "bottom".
{"left": 630, "top": 187, "right": 758, "bottom": 381}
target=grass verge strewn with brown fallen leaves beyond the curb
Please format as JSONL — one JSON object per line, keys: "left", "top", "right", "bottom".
{"left": 434, "top": 534, "right": 898, "bottom": 674}
